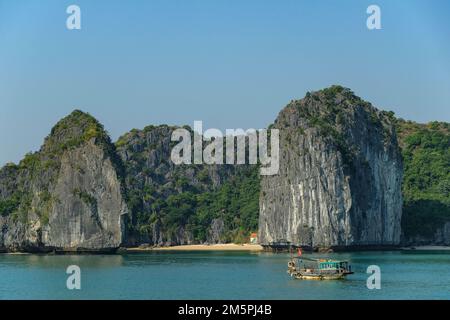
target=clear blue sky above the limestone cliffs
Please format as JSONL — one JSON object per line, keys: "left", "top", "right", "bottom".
{"left": 0, "top": 0, "right": 450, "bottom": 165}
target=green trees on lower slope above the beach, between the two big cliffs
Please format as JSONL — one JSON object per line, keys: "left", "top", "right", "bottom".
{"left": 128, "top": 166, "right": 260, "bottom": 243}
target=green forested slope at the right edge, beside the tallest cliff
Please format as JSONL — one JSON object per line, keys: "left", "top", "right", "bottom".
{"left": 397, "top": 120, "right": 450, "bottom": 237}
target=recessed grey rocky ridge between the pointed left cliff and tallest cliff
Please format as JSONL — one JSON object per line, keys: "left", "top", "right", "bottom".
{"left": 116, "top": 125, "right": 259, "bottom": 246}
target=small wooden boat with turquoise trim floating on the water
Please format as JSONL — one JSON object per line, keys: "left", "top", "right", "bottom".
{"left": 287, "top": 256, "right": 353, "bottom": 280}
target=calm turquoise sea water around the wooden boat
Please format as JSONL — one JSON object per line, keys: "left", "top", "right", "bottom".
{"left": 0, "top": 252, "right": 450, "bottom": 299}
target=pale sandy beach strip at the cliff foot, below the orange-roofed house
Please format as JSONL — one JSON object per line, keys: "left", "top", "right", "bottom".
{"left": 126, "top": 243, "right": 263, "bottom": 252}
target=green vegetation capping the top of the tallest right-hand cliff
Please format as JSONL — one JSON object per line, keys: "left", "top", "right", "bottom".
{"left": 282, "top": 85, "right": 395, "bottom": 169}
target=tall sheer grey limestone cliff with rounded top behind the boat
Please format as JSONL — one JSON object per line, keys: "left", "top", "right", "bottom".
{"left": 259, "top": 86, "right": 402, "bottom": 247}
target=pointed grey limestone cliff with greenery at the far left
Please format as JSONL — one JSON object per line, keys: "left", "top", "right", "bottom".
{"left": 0, "top": 111, "right": 127, "bottom": 251}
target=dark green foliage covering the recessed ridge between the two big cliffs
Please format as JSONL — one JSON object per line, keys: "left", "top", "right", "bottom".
{"left": 116, "top": 125, "right": 259, "bottom": 243}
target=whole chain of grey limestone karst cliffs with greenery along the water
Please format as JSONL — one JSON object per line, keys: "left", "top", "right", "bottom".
{"left": 0, "top": 86, "right": 450, "bottom": 252}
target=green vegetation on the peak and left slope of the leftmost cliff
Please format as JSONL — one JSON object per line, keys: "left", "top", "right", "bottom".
{"left": 0, "top": 110, "right": 122, "bottom": 224}
